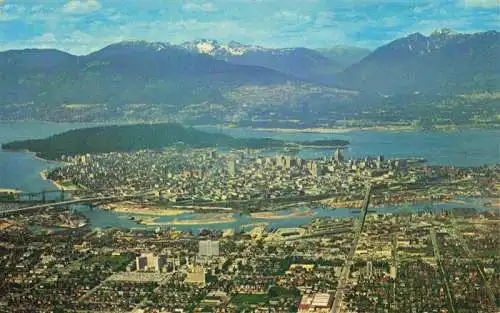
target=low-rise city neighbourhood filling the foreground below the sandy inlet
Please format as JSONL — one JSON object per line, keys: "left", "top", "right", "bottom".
{"left": 0, "top": 205, "right": 500, "bottom": 313}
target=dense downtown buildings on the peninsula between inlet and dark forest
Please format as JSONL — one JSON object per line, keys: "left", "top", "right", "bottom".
{"left": 49, "top": 148, "right": 500, "bottom": 204}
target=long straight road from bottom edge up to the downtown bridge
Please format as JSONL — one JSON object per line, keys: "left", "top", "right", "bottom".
{"left": 330, "top": 185, "right": 372, "bottom": 313}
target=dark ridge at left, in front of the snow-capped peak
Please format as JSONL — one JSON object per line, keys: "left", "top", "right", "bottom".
{"left": 0, "top": 42, "right": 298, "bottom": 104}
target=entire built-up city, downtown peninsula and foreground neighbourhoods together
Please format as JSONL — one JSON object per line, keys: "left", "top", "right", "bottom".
{"left": 0, "top": 147, "right": 500, "bottom": 313}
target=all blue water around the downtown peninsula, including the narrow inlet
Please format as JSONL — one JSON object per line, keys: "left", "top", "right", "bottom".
{"left": 0, "top": 122, "right": 500, "bottom": 231}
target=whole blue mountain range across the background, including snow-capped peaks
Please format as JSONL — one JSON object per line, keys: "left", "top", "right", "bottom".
{"left": 0, "top": 30, "right": 500, "bottom": 123}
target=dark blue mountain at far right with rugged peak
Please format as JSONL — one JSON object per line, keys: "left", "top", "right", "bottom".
{"left": 338, "top": 29, "right": 500, "bottom": 94}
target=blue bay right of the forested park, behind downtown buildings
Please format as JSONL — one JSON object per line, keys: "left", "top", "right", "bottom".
{"left": 200, "top": 126, "right": 500, "bottom": 167}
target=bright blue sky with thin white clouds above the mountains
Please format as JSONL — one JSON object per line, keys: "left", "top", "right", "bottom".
{"left": 0, "top": 0, "right": 500, "bottom": 54}
